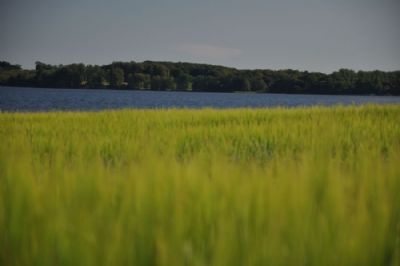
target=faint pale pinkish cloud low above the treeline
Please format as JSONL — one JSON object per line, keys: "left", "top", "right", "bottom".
{"left": 178, "top": 44, "right": 242, "bottom": 58}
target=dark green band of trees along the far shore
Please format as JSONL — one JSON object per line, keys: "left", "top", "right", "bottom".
{"left": 0, "top": 61, "right": 400, "bottom": 95}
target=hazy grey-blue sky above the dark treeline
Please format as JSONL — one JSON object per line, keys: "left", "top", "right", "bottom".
{"left": 0, "top": 0, "right": 400, "bottom": 73}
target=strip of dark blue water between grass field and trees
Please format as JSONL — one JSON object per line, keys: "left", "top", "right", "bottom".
{"left": 0, "top": 87, "right": 400, "bottom": 111}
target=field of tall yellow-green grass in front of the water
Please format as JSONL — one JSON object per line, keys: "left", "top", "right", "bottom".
{"left": 0, "top": 105, "right": 400, "bottom": 265}
